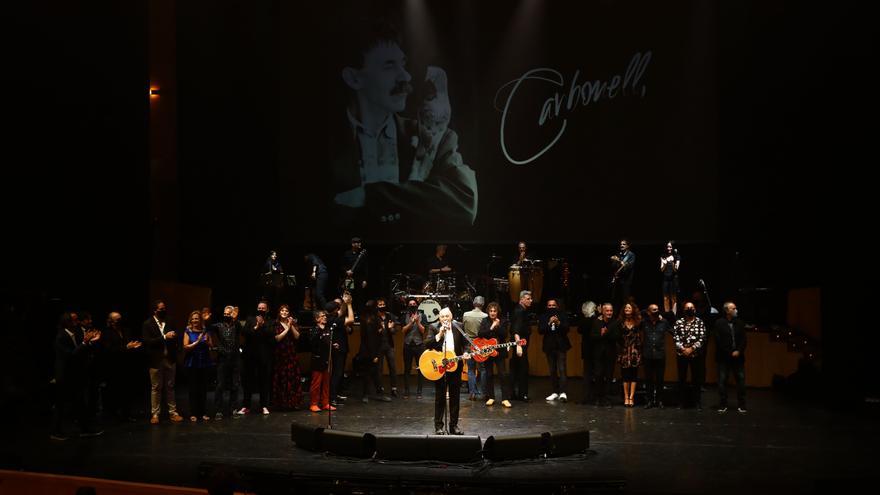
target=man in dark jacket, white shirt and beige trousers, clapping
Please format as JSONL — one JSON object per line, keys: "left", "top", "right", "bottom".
{"left": 142, "top": 300, "right": 183, "bottom": 425}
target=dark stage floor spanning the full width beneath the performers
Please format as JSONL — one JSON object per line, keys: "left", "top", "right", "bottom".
{"left": 2, "top": 379, "right": 880, "bottom": 493}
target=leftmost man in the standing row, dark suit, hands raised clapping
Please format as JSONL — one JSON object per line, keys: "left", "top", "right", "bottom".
{"left": 49, "top": 313, "right": 104, "bottom": 440}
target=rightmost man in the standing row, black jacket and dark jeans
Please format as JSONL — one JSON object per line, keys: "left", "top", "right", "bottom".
{"left": 712, "top": 301, "right": 746, "bottom": 413}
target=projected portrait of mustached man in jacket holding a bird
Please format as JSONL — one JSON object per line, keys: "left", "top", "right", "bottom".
{"left": 331, "top": 20, "right": 477, "bottom": 231}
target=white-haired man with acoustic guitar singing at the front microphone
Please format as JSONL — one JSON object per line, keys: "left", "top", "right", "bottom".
{"left": 425, "top": 307, "right": 470, "bottom": 435}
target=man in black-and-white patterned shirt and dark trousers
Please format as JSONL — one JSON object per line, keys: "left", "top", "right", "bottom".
{"left": 672, "top": 301, "right": 706, "bottom": 411}
